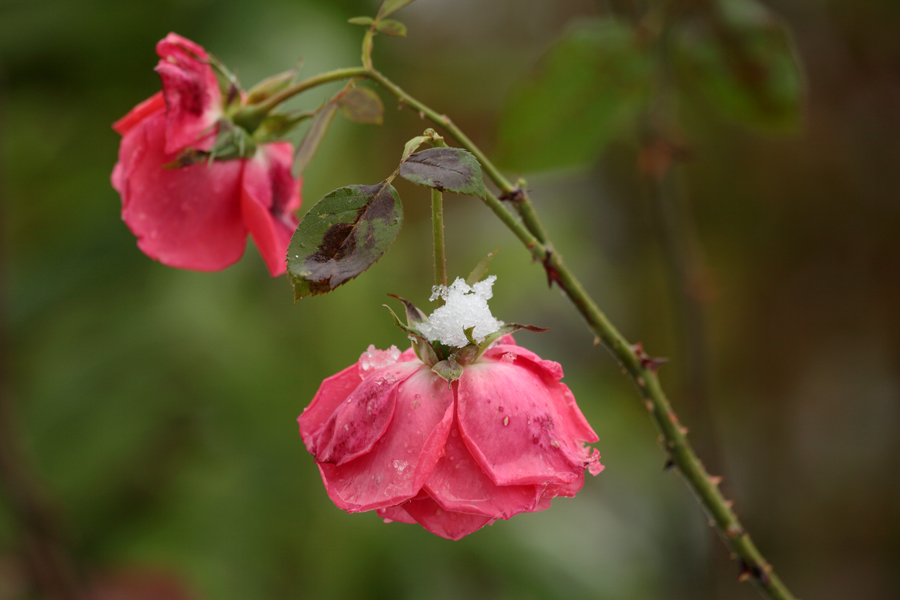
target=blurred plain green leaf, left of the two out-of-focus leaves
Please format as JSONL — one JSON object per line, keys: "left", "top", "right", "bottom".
{"left": 498, "top": 18, "right": 653, "bottom": 172}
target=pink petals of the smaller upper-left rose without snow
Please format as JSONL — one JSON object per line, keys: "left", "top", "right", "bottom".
{"left": 112, "top": 33, "right": 300, "bottom": 277}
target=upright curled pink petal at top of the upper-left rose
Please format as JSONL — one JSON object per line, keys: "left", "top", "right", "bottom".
{"left": 156, "top": 33, "right": 222, "bottom": 154}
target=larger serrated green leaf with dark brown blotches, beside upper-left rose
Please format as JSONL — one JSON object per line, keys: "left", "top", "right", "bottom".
{"left": 288, "top": 181, "right": 403, "bottom": 300}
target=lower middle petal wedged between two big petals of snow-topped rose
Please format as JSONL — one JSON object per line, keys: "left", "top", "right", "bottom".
{"left": 424, "top": 414, "right": 541, "bottom": 519}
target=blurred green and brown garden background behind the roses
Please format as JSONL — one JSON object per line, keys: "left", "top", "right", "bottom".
{"left": 0, "top": 0, "right": 900, "bottom": 600}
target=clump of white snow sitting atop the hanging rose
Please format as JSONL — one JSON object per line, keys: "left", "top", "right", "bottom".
{"left": 419, "top": 275, "right": 503, "bottom": 348}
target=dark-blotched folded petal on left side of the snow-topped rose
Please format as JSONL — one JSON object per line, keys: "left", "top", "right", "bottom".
{"left": 313, "top": 363, "right": 419, "bottom": 465}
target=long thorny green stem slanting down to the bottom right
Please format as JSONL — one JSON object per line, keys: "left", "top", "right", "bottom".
{"left": 366, "top": 70, "right": 794, "bottom": 600}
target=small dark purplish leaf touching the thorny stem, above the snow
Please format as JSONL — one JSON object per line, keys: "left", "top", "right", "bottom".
{"left": 400, "top": 148, "right": 487, "bottom": 197}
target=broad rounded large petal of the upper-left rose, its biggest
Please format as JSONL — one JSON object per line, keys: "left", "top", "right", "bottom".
{"left": 113, "top": 113, "right": 247, "bottom": 271}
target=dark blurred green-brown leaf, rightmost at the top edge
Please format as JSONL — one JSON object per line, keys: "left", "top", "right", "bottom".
{"left": 674, "top": 0, "right": 804, "bottom": 131}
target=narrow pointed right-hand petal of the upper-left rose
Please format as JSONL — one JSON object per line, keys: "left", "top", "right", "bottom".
{"left": 241, "top": 142, "right": 300, "bottom": 277}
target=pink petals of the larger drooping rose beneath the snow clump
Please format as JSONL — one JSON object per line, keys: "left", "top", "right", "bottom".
{"left": 297, "top": 336, "right": 603, "bottom": 540}
